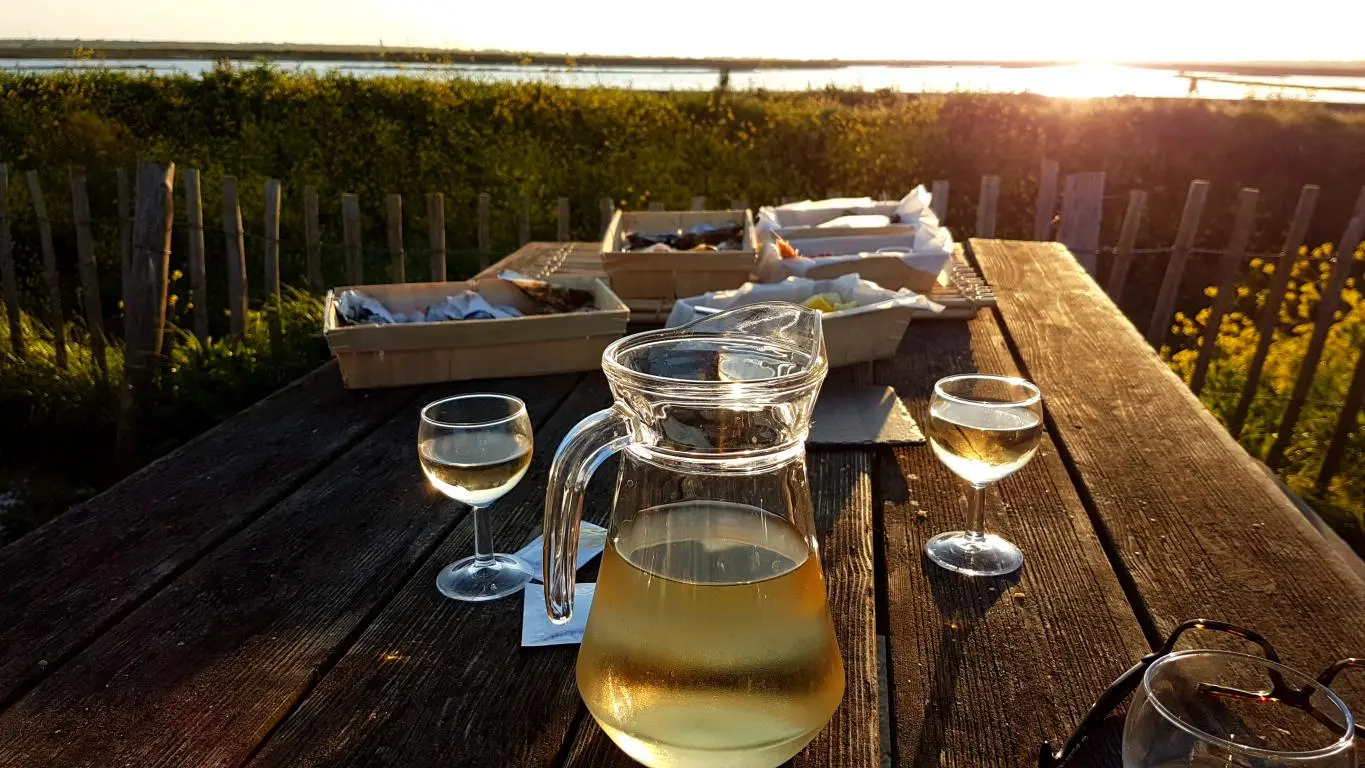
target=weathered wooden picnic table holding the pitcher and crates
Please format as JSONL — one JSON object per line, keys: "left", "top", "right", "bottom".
{"left": 0, "top": 240, "right": 1365, "bottom": 768}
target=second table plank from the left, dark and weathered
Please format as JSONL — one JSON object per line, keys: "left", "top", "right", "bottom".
{"left": 0, "top": 374, "right": 579, "bottom": 767}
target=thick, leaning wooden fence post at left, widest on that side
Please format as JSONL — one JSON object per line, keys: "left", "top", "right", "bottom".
{"left": 117, "top": 162, "right": 175, "bottom": 461}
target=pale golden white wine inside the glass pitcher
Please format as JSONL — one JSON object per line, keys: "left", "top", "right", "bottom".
{"left": 577, "top": 501, "right": 844, "bottom": 768}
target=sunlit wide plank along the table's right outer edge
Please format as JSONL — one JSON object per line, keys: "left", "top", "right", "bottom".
{"left": 971, "top": 240, "right": 1365, "bottom": 670}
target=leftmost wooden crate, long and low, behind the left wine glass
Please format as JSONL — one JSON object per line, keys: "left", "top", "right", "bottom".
{"left": 322, "top": 277, "right": 629, "bottom": 389}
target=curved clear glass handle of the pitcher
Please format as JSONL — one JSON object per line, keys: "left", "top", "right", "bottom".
{"left": 545, "top": 407, "right": 631, "bottom": 623}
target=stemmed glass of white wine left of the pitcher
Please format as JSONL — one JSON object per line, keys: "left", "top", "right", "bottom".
{"left": 418, "top": 394, "right": 532, "bottom": 600}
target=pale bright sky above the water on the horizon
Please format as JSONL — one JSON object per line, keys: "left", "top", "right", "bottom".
{"left": 8, "top": 0, "right": 1365, "bottom": 61}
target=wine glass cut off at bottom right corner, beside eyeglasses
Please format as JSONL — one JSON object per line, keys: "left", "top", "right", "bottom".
{"left": 1123, "top": 651, "right": 1355, "bottom": 768}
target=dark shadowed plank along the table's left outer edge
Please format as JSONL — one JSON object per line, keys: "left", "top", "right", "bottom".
{"left": 0, "top": 363, "right": 414, "bottom": 707}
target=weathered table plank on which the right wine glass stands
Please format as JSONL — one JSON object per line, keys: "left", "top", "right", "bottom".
{"left": 874, "top": 312, "right": 1147, "bottom": 768}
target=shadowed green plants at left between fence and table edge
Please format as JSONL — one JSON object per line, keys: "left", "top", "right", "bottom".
{"left": 0, "top": 289, "right": 328, "bottom": 542}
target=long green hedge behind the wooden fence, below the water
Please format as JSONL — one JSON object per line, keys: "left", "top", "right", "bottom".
{"left": 8, "top": 68, "right": 1365, "bottom": 338}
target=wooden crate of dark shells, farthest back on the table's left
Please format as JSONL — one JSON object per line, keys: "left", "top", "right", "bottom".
{"left": 602, "top": 210, "right": 759, "bottom": 306}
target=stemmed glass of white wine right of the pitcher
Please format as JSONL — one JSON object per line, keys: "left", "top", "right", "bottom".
{"left": 924, "top": 374, "right": 1043, "bottom": 576}
